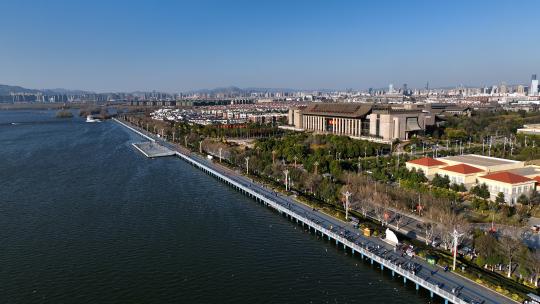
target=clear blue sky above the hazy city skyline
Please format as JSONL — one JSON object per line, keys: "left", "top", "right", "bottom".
{"left": 0, "top": 0, "right": 540, "bottom": 92}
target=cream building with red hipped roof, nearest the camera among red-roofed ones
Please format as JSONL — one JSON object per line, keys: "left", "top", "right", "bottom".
{"left": 478, "top": 171, "right": 536, "bottom": 204}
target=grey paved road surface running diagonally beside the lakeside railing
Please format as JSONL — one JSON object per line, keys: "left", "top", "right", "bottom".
{"left": 119, "top": 118, "right": 516, "bottom": 304}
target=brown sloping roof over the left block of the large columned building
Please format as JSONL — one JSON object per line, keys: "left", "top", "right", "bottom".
{"left": 302, "top": 103, "right": 373, "bottom": 118}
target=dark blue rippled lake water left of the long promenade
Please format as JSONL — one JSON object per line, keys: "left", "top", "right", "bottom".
{"left": 0, "top": 111, "right": 430, "bottom": 304}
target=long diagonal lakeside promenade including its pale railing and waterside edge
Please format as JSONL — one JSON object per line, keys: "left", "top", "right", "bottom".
{"left": 115, "top": 119, "right": 516, "bottom": 304}
